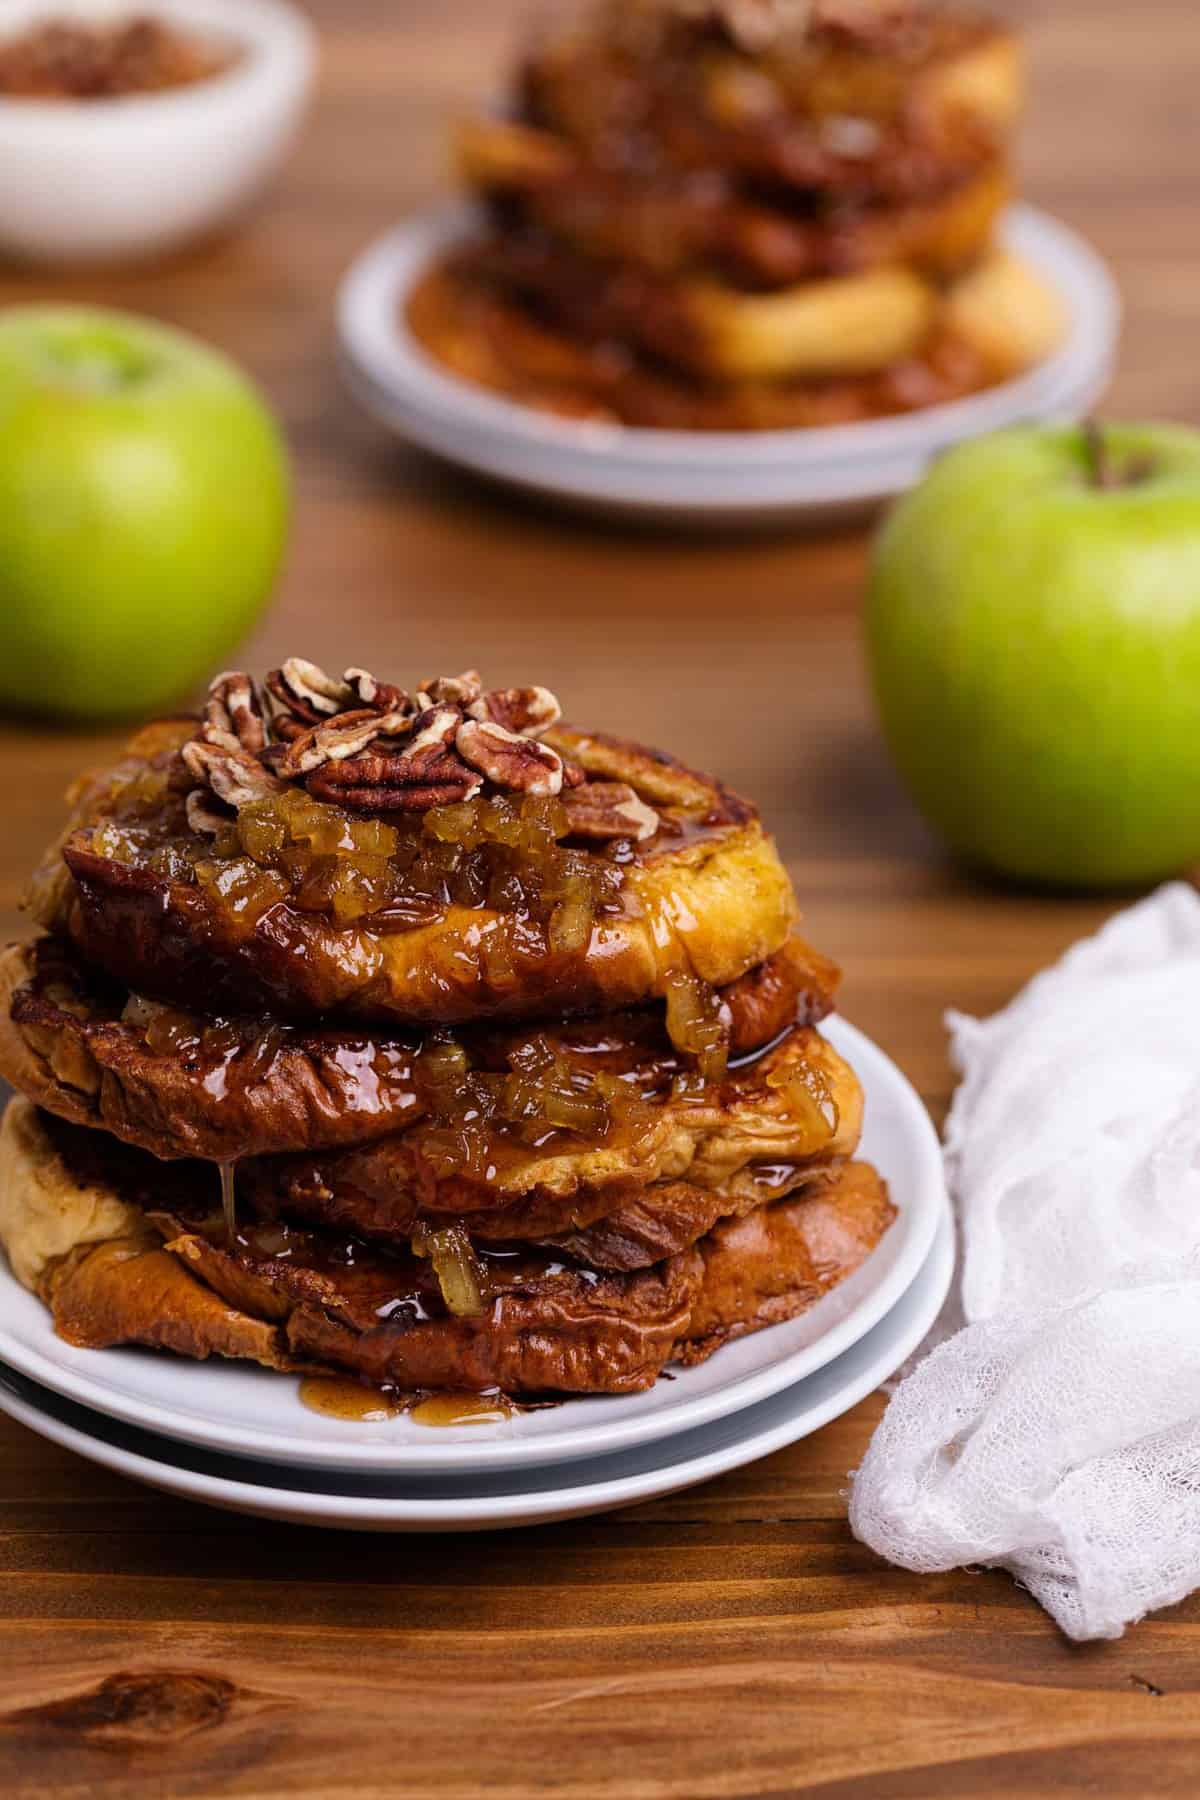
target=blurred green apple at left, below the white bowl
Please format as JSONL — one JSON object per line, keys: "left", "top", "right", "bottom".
{"left": 0, "top": 306, "right": 288, "bottom": 718}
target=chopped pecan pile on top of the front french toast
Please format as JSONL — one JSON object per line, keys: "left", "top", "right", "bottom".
{"left": 182, "top": 657, "right": 568, "bottom": 835}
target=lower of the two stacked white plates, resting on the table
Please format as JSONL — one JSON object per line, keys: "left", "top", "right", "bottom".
{"left": 0, "top": 1199, "right": 954, "bottom": 1532}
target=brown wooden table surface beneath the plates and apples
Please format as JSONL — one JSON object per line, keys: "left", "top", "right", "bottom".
{"left": 0, "top": 0, "right": 1200, "bottom": 1800}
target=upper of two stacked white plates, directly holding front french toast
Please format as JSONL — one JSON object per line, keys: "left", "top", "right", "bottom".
{"left": 0, "top": 1017, "right": 945, "bottom": 1474}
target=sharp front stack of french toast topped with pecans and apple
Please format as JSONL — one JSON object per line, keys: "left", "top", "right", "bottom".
{"left": 0, "top": 659, "right": 894, "bottom": 1399}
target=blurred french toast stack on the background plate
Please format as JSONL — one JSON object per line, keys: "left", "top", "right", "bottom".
{"left": 408, "top": 0, "right": 1063, "bottom": 428}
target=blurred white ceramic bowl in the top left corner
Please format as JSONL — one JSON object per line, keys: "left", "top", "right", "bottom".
{"left": 0, "top": 0, "right": 315, "bottom": 263}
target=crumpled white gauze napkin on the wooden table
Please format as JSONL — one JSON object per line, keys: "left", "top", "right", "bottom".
{"left": 851, "top": 884, "right": 1200, "bottom": 1638}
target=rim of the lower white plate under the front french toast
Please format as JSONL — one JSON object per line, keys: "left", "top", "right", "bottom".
{"left": 0, "top": 1199, "right": 954, "bottom": 1532}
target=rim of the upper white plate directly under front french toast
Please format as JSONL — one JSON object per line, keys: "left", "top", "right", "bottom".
{"left": 0, "top": 1015, "right": 945, "bottom": 1474}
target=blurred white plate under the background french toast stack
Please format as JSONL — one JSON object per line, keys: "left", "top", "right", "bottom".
{"left": 338, "top": 207, "right": 1121, "bottom": 524}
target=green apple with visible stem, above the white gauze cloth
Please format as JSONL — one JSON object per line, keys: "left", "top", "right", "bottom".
{"left": 867, "top": 425, "right": 1200, "bottom": 887}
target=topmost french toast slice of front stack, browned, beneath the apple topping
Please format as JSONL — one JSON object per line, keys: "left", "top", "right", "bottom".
{"left": 36, "top": 727, "right": 795, "bottom": 1026}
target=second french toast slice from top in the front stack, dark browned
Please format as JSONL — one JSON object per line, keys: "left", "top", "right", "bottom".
{"left": 0, "top": 938, "right": 838, "bottom": 1161}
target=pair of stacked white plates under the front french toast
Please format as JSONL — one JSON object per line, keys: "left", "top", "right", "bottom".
{"left": 0, "top": 1019, "right": 954, "bottom": 1532}
